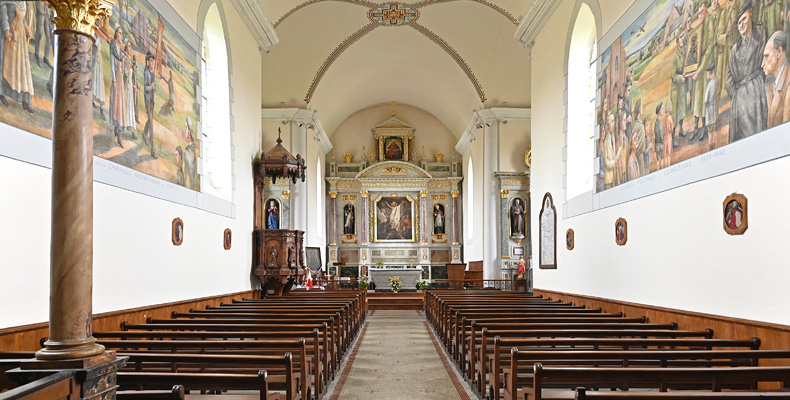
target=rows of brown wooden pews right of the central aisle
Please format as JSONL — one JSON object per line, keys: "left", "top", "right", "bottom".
{"left": 425, "top": 290, "right": 790, "bottom": 400}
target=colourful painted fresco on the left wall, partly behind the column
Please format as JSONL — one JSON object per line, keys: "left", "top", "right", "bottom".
{"left": 0, "top": 0, "right": 200, "bottom": 190}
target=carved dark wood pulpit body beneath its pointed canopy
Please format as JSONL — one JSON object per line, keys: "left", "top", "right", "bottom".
{"left": 253, "top": 229, "right": 306, "bottom": 296}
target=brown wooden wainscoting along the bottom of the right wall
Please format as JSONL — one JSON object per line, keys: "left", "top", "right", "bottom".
{"left": 534, "top": 289, "right": 790, "bottom": 372}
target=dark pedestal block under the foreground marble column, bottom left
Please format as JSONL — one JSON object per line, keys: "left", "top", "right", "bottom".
{"left": 7, "top": 351, "right": 128, "bottom": 400}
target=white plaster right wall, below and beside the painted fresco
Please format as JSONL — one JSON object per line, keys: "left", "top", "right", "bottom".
{"left": 531, "top": 0, "right": 790, "bottom": 324}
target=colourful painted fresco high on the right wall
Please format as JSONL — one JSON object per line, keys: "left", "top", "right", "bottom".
{"left": 596, "top": 0, "right": 790, "bottom": 192}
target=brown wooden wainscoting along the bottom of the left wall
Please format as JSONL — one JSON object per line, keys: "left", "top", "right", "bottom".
{"left": 0, "top": 290, "right": 260, "bottom": 351}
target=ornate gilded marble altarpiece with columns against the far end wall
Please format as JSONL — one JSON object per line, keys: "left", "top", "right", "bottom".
{"left": 326, "top": 113, "right": 463, "bottom": 289}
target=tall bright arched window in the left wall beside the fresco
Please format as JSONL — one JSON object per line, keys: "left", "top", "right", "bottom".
{"left": 202, "top": 3, "right": 233, "bottom": 200}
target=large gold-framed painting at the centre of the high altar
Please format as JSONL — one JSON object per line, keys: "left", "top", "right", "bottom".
{"left": 374, "top": 196, "right": 415, "bottom": 242}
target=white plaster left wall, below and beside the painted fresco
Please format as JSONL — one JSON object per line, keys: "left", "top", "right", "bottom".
{"left": 0, "top": 0, "right": 261, "bottom": 328}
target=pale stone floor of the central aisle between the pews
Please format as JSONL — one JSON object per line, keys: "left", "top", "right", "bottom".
{"left": 329, "top": 310, "right": 470, "bottom": 400}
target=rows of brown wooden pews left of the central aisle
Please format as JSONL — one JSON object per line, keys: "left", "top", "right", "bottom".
{"left": 0, "top": 290, "right": 367, "bottom": 400}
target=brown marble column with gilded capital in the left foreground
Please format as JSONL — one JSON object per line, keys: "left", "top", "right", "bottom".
{"left": 36, "top": 0, "right": 114, "bottom": 360}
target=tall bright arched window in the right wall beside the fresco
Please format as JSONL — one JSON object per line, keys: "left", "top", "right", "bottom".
{"left": 566, "top": 3, "right": 596, "bottom": 199}
